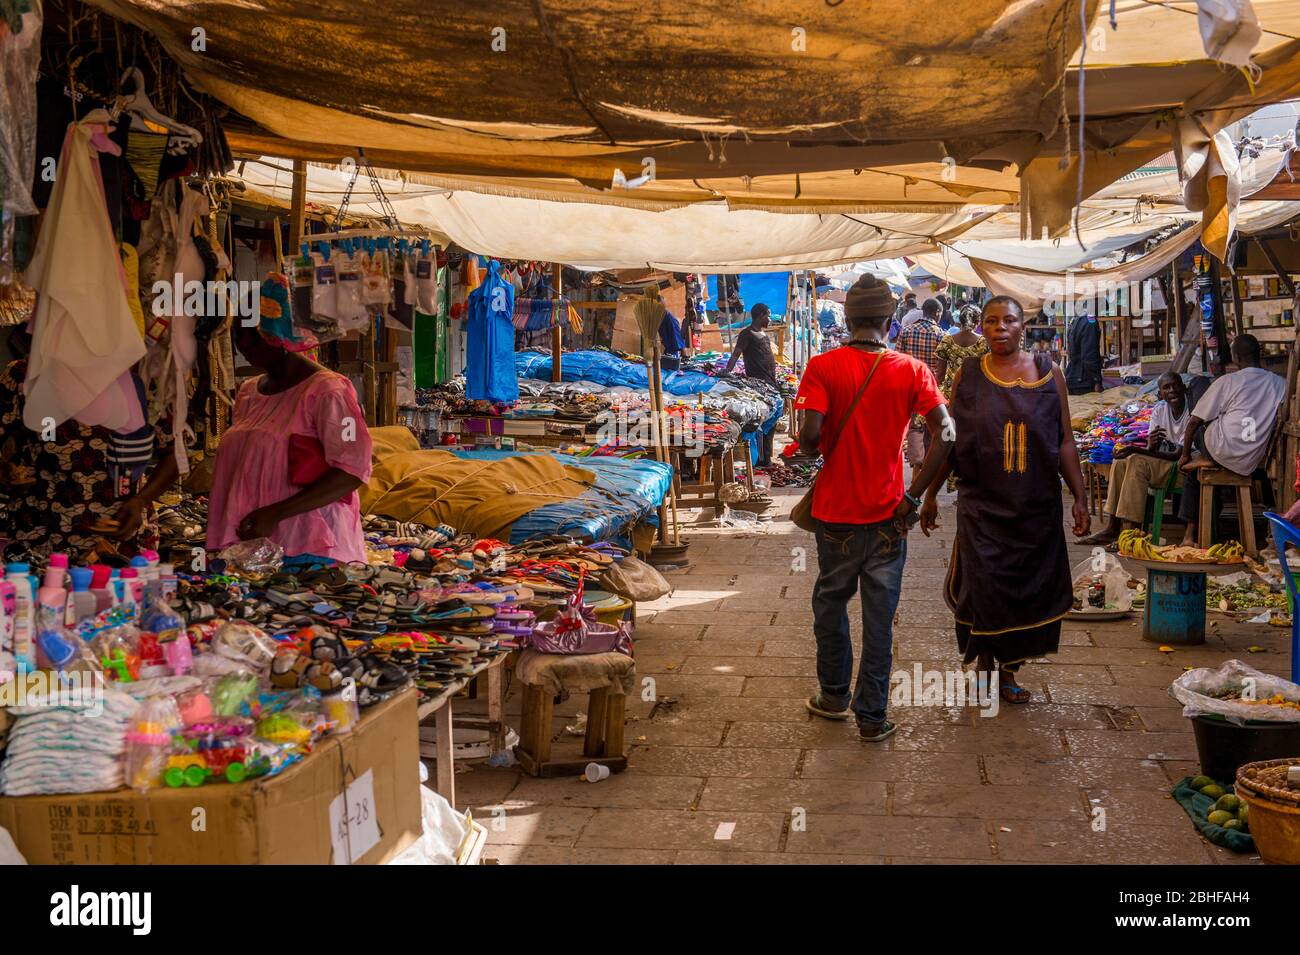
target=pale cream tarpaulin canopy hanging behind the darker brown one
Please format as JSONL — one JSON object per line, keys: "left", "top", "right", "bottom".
{"left": 234, "top": 151, "right": 1300, "bottom": 270}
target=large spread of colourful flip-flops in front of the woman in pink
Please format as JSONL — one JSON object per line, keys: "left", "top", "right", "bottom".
{"left": 176, "top": 525, "right": 625, "bottom": 706}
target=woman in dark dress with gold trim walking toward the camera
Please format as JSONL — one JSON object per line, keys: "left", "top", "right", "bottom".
{"left": 920, "top": 295, "right": 1089, "bottom": 703}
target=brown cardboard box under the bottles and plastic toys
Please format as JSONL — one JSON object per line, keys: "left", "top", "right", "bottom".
{"left": 0, "top": 690, "right": 421, "bottom": 865}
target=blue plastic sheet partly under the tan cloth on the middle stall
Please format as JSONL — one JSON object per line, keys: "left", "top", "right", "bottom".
{"left": 454, "top": 446, "right": 672, "bottom": 544}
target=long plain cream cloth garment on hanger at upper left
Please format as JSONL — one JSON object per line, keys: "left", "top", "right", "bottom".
{"left": 23, "top": 113, "right": 144, "bottom": 430}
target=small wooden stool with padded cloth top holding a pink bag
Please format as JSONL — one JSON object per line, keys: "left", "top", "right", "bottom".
{"left": 515, "top": 650, "right": 636, "bottom": 777}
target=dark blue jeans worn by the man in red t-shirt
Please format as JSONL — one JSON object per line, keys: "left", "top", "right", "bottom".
{"left": 813, "top": 520, "right": 907, "bottom": 726}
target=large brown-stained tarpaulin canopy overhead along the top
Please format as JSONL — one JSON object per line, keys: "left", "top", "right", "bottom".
{"left": 94, "top": 0, "right": 1300, "bottom": 234}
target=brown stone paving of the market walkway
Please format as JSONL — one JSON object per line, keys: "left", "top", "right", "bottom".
{"left": 456, "top": 489, "right": 1290, "bottom": 864}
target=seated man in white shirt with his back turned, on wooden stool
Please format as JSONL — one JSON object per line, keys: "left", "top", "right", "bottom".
{"left": 1178, "top": 335, "right": 1287, "bottom": 546}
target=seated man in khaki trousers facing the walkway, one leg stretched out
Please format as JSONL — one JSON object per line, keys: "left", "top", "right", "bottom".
{"left": 1079, "top": 372, "right": 1191, "bottom": 544}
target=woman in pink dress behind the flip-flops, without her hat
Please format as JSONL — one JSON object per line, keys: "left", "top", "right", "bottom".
{"left": 208, "top": 325, "right": 371, "bottom": 563}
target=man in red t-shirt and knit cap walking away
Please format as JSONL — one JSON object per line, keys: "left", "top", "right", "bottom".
{"left": 794, "top": 275, "right": 956, "bottom": 742}
